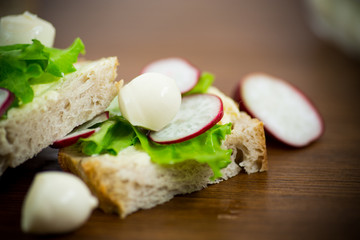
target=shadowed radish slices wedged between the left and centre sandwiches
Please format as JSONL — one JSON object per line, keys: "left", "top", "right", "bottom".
{"left": 51, "top": 112, "right": 109, "bottom": 148}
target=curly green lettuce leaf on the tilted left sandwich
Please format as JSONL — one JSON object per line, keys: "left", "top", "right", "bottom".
{"left": 0, "top": 38, "right": 85, "bottom": 106}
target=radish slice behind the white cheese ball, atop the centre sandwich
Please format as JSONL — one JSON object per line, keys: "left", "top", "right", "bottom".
{"left": 142, "top": 58, "right": 201, "bottom": 94}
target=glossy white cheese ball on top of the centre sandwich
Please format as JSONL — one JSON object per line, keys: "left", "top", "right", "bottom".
{"left": 118, "top": 73, "right": 181, "bottom": 131}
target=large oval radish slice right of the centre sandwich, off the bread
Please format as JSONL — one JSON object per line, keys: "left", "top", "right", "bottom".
{"left": 235, "top": 74, "right": 324, "bottom": 147}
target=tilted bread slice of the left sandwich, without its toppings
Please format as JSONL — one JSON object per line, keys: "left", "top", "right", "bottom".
{"left": 0, "top": 57, "right": 118, "bottom": 175}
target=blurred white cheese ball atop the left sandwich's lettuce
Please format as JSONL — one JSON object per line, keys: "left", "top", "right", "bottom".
{"left": 0, "top": 12, "right": 55, "bottom": 47}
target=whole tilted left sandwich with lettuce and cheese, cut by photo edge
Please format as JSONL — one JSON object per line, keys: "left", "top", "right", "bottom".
{"left": 0, "top": 12, "right": 118, "bottom": 175}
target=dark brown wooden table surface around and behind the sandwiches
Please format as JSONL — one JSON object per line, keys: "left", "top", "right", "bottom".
{"left": 0, "top": 0, "right": 360, "bottom": 240}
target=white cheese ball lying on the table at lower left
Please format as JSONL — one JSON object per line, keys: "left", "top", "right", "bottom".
{"left": 21, "top": 171, "right": 98, "bottom": 234}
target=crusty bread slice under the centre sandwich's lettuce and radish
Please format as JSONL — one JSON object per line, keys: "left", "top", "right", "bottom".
{"left": 59, "top": 88, "right": 267, "bottom": 218}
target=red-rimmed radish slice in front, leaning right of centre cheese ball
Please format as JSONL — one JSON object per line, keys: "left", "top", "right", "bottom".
{"left": 149, "top": 94, "right": 224, "bottom": 144}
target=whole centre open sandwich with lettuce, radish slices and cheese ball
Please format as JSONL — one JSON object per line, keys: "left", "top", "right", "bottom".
{"left": 58, "top": 58, "right": 268, "bottom": 218}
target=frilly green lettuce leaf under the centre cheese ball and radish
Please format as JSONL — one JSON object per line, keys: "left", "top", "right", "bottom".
{"left": 78, "top": 116, "right": 232, "bottom": 180}
